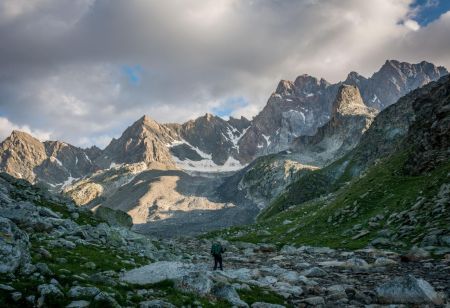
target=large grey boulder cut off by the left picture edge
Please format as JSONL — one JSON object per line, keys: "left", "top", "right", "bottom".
{"left": 0, "top": 217, "right": 31, "bottom": 274}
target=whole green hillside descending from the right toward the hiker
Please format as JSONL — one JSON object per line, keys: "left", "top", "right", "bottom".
{"left": 210, "top": 153, "right": 450, "bottom": 254}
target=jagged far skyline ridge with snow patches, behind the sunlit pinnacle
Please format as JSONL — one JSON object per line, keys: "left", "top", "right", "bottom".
{"left": 0, "top": 60, "right": 447, "bottom": 189}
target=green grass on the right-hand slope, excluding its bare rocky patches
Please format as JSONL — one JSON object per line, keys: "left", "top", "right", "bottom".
{"left": 211, "top": 153, "right": 450, "bottom": 249}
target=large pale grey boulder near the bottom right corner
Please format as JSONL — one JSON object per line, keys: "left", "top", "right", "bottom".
{"left": 375, "top": 275, "right": 442, "bottom": 305}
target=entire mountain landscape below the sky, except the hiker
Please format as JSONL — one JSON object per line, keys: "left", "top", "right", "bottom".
{"left": 0, "top": 60, "right": 450, "bottom": 308}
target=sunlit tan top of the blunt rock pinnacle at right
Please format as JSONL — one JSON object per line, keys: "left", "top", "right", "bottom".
{"left": 332, "top": 84, "right": 368, "bottom": 116}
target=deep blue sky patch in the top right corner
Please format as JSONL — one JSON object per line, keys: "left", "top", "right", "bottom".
{"left": 411, "top": 0, "right": 450, "bottom": 27}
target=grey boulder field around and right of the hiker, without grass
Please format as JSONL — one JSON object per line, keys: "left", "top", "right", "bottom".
{"left": 120, "top": 239, "right": 450, "bottom": 307}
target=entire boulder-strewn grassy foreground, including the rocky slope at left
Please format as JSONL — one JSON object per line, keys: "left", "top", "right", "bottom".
{"left": 0, "top": 175, "right": 450, "bottom": 307}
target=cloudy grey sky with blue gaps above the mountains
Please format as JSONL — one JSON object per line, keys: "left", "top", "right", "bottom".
{"left": 0, "top": 0, "right": 450, "bottom": 147}
